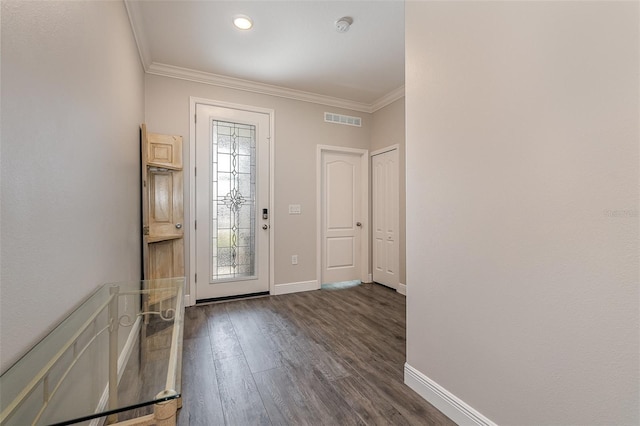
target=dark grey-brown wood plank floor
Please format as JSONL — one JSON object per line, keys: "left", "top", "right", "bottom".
{"left": 178, "top": 284, "right": 454, "bottom": 426}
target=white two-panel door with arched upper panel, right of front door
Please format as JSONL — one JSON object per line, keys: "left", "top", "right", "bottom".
{"left": 320, "top": 151, "right": 366, "bottom": 284}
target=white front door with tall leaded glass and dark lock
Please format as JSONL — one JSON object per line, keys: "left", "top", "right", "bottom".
{"left": 195, "top": 103, "right": 271, "bottom": 300}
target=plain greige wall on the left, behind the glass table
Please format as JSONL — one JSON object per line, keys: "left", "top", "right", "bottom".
{"left": 0, "top": 0, "right": 144, "bottom": 371}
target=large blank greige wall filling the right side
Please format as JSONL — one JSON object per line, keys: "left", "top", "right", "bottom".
{"left": 406, "top": 2, "right": 640, "bottom": 425}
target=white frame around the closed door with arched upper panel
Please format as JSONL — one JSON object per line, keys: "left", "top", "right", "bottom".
{"left": 316, "top": 145, "right": 371, "bottom": 289}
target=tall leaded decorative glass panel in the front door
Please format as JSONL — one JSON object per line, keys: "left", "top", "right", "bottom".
{"left": 210, "top": 120, "right": 256, "bottom": 283}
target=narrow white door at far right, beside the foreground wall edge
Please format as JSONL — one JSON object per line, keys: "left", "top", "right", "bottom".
{"left": 371, "top": 148, "right": 400, "bottom": 289}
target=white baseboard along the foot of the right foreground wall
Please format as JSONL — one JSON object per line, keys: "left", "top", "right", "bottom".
{"left": 404, "top": 363, "right": 497, "bottom": 426}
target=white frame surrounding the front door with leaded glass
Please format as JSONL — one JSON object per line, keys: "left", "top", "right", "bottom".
{"left": 185, "top": 96, "right": 275, "bottom": 306}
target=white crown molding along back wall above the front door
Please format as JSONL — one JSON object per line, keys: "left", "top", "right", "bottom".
{"left": 146, "top": 62, "right": 373, "bottom": 113}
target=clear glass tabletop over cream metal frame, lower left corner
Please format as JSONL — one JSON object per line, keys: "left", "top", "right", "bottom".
{"left": 0, "top": 278, "right": 184, "bottom": 426}
